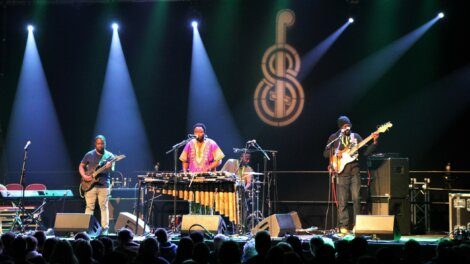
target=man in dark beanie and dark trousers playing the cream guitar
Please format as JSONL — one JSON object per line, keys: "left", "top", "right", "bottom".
{"left": 323, "top": 116, "right": 379, "bottom": 234}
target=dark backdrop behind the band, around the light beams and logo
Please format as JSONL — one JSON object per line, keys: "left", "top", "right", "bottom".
{"left": 0, "top": 0, "right": 470, "bottom": 229}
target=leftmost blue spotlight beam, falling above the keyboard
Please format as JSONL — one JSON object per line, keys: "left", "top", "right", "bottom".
{"left": 3, "top": 25, "right": 72, "bottom": 179}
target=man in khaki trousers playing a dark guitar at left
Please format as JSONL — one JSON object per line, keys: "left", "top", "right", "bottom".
{"left": 78, "top": 135, "right": 114, "bottom": 235}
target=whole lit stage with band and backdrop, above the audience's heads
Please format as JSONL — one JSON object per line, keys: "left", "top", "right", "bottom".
{"left": 0, "top": 0, "right": 470, "bottom": 260}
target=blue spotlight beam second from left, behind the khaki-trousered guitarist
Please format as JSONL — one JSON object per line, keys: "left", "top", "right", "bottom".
{"left": 93, "top": 23, "right": 153, "bottom": 177}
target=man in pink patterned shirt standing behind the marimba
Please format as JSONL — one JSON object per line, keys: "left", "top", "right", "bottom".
{"left": 180, "top": 123, "right": 225, "bottom": 172}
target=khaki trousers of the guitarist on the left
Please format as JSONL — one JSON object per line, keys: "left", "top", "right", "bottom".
{"left": 85, "top": 187, "right": 110, "bottom": 228}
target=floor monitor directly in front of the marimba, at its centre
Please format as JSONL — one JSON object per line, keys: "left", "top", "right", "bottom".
{"left": 181, "top": 215, "right": 226, "bottom": 234}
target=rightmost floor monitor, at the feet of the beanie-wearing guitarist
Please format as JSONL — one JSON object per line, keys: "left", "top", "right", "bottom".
{"left": 354, "top": 215, "right": 400, "bottom": 240}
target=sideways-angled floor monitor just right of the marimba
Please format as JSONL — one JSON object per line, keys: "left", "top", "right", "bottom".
{"left": 251, "top": 214, "right": 300, "bottom": 237}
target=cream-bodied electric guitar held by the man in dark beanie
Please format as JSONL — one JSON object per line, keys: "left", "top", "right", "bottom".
{"left": 330, "top": 122, "right": 393, "bottom": 173}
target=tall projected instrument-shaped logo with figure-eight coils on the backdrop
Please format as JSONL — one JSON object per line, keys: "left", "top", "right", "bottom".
{"left": 254, "top": 9, "right": 304, "bottom": 126}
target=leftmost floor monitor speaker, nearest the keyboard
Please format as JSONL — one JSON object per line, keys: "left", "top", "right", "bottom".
{"left": 54, "top": 213, "right": 101, "bottom": 236}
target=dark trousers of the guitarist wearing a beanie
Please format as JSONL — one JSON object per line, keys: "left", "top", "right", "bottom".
{"left": 336, "top": 173, "right": 361, "bottom": 228}
